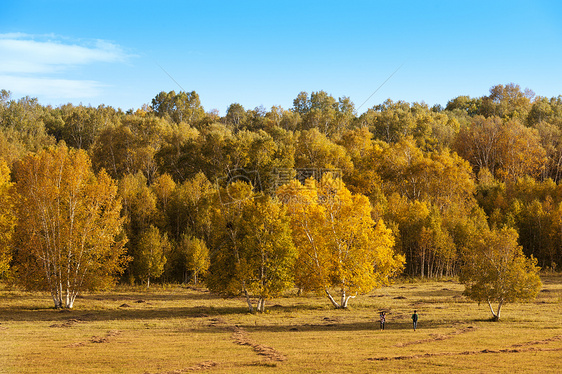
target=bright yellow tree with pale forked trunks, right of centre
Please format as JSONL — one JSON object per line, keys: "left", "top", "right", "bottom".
{"left": 277, "top": 175, "right": 404, "bottom": 308}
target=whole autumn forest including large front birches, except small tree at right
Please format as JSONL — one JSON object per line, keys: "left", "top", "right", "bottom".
{"left": 0, "top": 83, "right": 562, "bottom": 310}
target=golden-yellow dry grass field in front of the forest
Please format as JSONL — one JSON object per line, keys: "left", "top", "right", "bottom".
{"left": 0, "top": 276, "right": 562, "bottom": 374}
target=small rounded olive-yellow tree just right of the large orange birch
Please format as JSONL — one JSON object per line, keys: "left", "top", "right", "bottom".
{"left": 136, "top": 225, "right": 170, "bottom": 288}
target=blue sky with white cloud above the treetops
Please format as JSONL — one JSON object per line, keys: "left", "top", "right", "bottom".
{"left": 0, "top": 0, "right": 562, "bottom": 114}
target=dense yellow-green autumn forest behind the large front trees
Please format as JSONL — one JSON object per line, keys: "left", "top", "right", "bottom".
{"left": 0, "top": 84, "right": 562, "bottom": 288}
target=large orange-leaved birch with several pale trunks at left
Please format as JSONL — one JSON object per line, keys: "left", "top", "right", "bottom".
{"left": 14, "top": 146, "right": 126, "bottom": 308}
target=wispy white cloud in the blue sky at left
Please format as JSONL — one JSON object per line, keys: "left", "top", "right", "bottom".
{"left": 0, "top": 33, "right": 131, "bottom": 100}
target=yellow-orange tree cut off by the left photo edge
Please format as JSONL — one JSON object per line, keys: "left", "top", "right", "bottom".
{"left": 0, "top": 158, "right": 15, "bottom": 278}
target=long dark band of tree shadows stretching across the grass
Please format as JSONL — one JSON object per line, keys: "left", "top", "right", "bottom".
{"left": 0, "top": 297, "right": 464, "bottom": 333}
